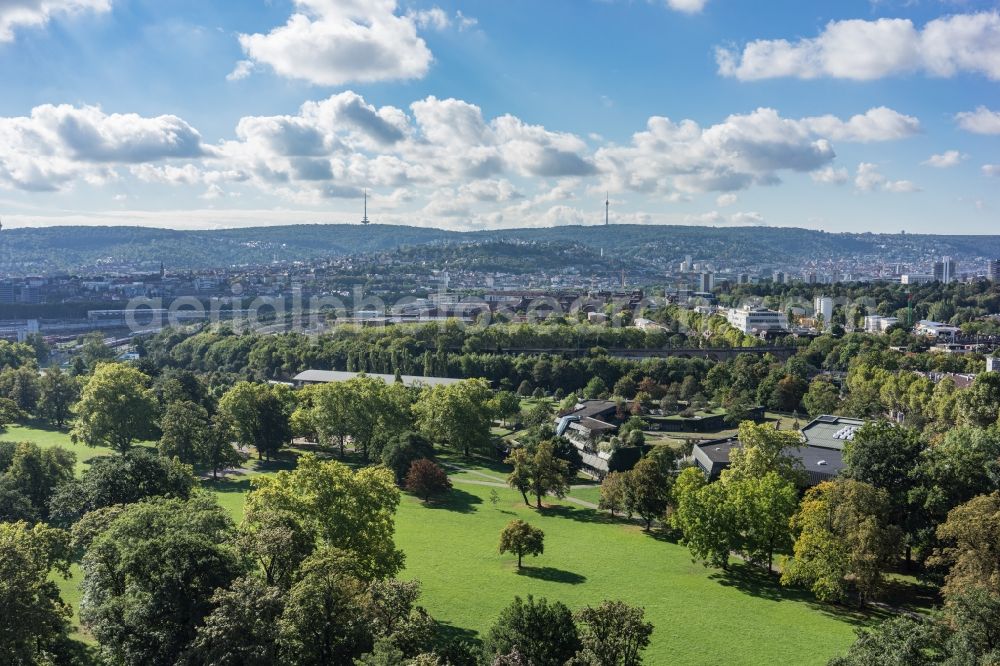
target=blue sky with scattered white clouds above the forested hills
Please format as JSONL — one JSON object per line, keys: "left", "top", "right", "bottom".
{"left": 0, "top": 0, "right": 1000, "bottom": 233}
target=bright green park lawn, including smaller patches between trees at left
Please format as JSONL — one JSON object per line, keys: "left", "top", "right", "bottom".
{"left": 0, "top": 427, "right": 872, "bottom": 664}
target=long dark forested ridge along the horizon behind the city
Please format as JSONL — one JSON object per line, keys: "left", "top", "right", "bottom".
{"left": 0, "top": 224, "right": 1000, "bottom": 275}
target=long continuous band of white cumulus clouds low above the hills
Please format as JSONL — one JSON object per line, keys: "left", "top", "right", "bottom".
{"left": 0, "top": 90, "right": 920, "bottom": 225}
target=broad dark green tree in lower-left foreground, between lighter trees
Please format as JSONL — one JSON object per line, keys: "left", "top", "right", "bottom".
{"left": 80, "top": 496, "right": 241, "bottom": 665}
